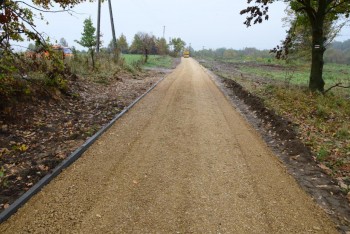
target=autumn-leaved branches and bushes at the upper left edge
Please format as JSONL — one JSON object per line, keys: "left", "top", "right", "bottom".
{"left": 0, "top": 0, "right": 101, "bottom": 104}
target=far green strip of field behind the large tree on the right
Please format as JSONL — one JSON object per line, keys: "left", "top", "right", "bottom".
{"left": 208, "top": 52, "right": 350, "bottom": 89}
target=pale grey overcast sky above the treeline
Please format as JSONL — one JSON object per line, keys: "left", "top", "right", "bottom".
{"left": 19, "top": 0, "right": 350, "bottom": 50}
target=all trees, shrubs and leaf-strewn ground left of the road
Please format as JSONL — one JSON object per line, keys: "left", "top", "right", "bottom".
{"left": 0, "top": 0, "right": 185, "bottom": 211}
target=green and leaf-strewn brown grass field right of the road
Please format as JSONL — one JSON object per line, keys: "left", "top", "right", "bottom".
{"left": 203, "top": 58, "right": 350, "bottom": 177}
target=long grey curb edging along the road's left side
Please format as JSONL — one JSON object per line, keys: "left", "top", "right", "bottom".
{"left": 0, "top": 76, "right": 166, "bottom": 224}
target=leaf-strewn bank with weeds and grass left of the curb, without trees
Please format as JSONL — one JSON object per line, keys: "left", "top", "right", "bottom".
{"left": 0, "top": 32, "right": 183, "bottom": 211}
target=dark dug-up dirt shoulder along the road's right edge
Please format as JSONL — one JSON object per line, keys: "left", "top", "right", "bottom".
{"left": 198, "top": 59, "right": 350, "bottom": 232}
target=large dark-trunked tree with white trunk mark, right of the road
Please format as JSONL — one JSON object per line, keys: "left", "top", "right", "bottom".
{"left": 241, "top": 0, "right": 350, "bottom": 92}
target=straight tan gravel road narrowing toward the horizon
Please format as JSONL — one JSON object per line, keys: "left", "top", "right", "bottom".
{"left": 0, "top": 59, "right": 337, "bottom": 234}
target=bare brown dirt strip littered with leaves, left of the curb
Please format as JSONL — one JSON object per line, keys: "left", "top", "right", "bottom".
{"left": 0, "top": 69, "right": 170, "bottom": 212}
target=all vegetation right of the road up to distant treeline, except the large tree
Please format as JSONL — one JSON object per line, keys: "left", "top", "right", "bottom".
{"left": 194, "top": 44, "right": 350, "bottom": 189}
